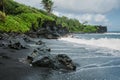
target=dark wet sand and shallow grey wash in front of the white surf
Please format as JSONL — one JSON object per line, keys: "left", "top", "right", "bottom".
{"left": 0, "top": 39, "right": 120, "bottom": 80}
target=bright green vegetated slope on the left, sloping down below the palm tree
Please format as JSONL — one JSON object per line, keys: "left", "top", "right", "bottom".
{"left": 0, "top": 0, "right": 54, "bottom": 32}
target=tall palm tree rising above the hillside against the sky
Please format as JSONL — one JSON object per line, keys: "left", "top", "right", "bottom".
{"left": 42, "top": 0, "right": 54, "bottom": 13}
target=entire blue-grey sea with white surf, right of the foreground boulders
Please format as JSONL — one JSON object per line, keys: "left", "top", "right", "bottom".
{"left": 40, "top": 32, "right": 120, "bottom": 80}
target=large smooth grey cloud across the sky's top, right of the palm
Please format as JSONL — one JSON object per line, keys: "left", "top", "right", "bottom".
{"left": 53, "top": 0, "right": 120, "bottom": 13}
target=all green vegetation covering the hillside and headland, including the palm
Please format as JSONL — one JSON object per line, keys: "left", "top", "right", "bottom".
{"left": 0, "top": 0, "right": 97, "bottom": 33}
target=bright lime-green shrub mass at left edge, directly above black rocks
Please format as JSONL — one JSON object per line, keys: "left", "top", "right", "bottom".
{"left": 0, "top": 16, "right": 29, "bottom": 33}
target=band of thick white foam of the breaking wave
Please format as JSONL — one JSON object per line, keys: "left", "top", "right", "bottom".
{"left": 59, "top": 38, "right": 120, "bottom": 50}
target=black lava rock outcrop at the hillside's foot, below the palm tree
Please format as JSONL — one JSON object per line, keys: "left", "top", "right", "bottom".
{"left": 26, "top": 21, "right": 69, "bottom": 39}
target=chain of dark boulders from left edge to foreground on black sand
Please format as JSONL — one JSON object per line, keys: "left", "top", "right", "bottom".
{"left": 0, "top": 31, "right": 76, "bottom": 70}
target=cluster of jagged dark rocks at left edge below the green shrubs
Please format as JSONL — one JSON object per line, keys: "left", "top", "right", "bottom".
{"left": 0, "top": 33, "right": 31, "bottom": 50}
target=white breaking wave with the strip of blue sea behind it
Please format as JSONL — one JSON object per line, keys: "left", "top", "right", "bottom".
{"left": 61, "top": 33, "right": 120, "bottom": 50}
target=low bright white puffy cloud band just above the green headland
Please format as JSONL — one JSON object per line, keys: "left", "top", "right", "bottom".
{"left": 53, "top": 11, "right": 109, "bottom": 24}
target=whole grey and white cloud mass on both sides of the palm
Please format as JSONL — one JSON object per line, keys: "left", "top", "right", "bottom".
{"left": 15, "top": 0, "right": 111, "bottom": 24}
